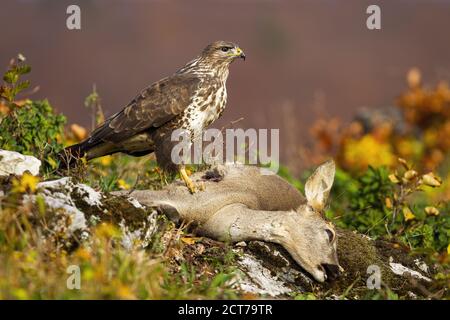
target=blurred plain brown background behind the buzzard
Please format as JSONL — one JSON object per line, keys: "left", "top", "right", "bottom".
{"left": 0, "top": 0, "right": 450, "bottom": 166}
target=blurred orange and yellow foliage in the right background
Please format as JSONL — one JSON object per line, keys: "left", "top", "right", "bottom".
{"left": 303, "top": 68, "right": 450, "bottom": 172}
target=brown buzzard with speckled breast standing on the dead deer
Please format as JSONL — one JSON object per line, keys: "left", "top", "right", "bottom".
{"left": 62, "top": 41, "right": 245, "bottom": 192}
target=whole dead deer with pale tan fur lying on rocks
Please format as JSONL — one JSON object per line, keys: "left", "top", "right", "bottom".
{"left": 119, "top": 161, "right": 342, "bottom": 282}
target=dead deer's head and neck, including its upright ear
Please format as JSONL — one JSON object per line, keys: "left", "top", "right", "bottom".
{"left": 201, "top": 161, "right": 343, "bottom": 282}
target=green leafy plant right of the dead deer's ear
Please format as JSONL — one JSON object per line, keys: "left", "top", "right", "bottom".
{"left": 328, "top": 159, "right": 450, "bottom": 253}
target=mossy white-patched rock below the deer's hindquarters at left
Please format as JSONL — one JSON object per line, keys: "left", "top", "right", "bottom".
{"left": 23, "top": 177, "right": 160, "bottom": 249}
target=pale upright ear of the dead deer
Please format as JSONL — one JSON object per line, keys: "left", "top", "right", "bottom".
{"left": 305, "top": 160, "right": 336, "bottom": 211}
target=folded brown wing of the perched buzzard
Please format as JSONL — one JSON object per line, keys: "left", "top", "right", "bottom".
{"left": 88, "top": 74, "right": 200, "bottom": 146}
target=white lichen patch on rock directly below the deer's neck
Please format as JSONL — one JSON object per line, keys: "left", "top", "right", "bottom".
{"left": 238, "top": 254, "right": 291, "bottom": 297}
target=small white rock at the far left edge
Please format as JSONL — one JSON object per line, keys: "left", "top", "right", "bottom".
{"left": 0, "top": 150, "right": 41, "bottom": 176}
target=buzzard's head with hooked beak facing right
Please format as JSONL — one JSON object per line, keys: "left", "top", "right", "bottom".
{"left": 202, "top": 41, "right": 245, "bottom": 65}
